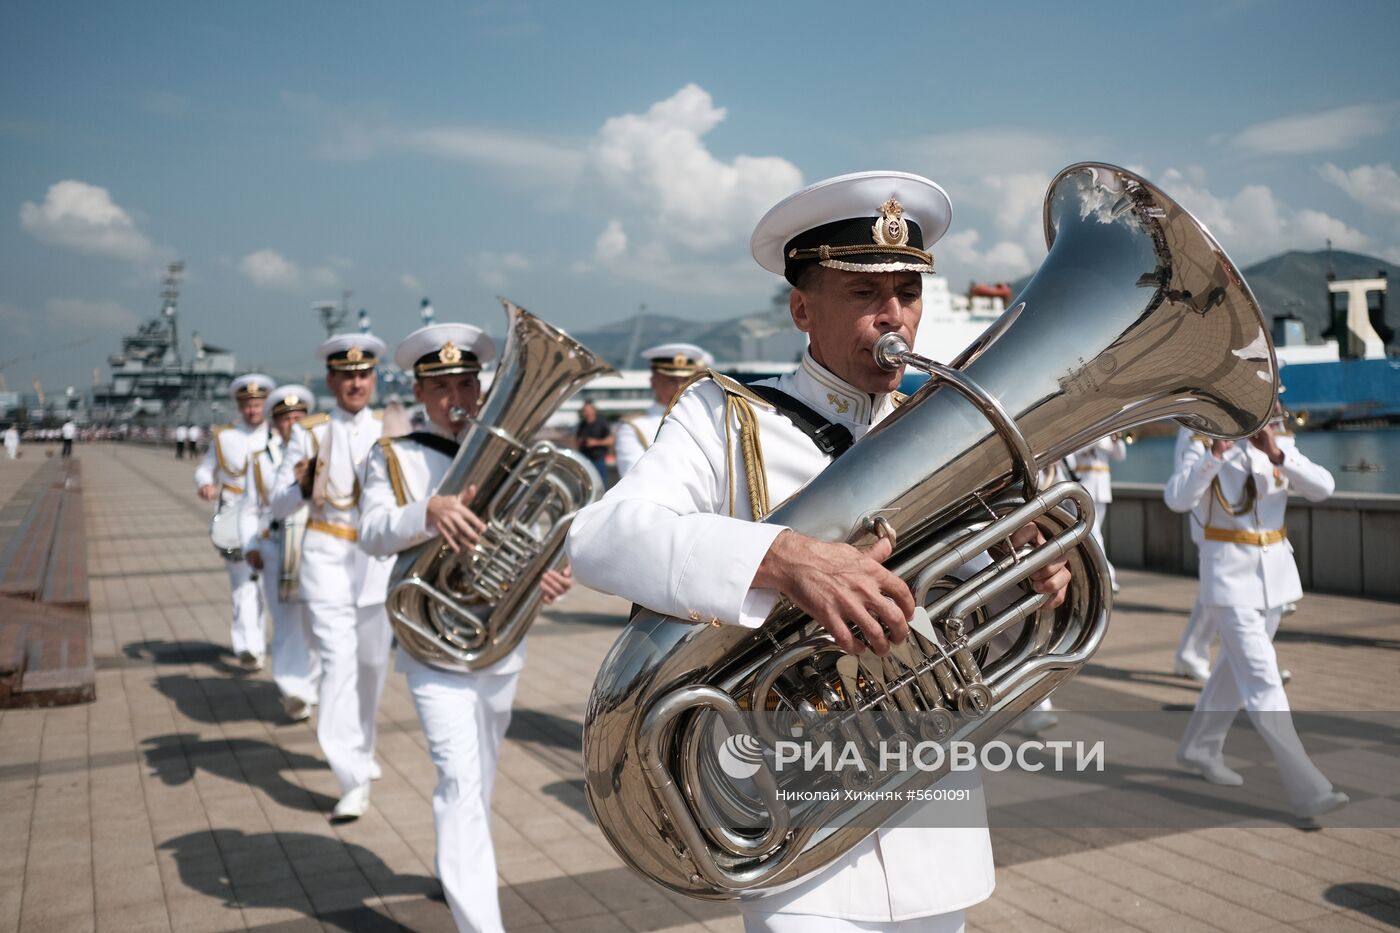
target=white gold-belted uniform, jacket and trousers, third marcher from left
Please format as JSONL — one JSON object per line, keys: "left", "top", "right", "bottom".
{"left": 270, "top": 406, "right": 393, "bottom": 793}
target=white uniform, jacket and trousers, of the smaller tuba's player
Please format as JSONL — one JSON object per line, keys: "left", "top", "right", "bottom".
{"left": 360, "top": 423, "right": 525, "bottom": 930}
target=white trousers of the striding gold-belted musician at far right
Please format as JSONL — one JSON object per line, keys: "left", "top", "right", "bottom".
{"left": 1179, "top": 607, "right": 1331, "bottom": 807}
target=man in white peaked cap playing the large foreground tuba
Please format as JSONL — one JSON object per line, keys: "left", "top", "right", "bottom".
{"left": 568, "top": 172, "right": 1070, "bottom": 930}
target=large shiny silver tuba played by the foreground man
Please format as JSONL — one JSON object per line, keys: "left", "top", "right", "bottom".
{"left": 584, "top": 163, "right": 1278, "bottom": 898}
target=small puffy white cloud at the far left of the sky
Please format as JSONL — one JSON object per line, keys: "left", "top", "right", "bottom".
{"left": 20, "top": 179, "right": 157, "bottom": 262}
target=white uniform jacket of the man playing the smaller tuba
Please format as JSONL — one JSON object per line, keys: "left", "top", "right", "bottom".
{"left": 360, "top": 423, "right": 525, "bottom": 674}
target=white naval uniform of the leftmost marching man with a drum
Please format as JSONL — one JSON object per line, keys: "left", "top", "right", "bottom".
{"left": 195, "top": 422, "right": 267, "bottom": 658}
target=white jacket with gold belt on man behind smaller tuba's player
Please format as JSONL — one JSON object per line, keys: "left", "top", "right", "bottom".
{"left": 269, "top": 406, "right": 393, "bottom": 608}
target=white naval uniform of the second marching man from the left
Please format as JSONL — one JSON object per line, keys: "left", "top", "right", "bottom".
{"left": 238, "top": 431, "right": 321, "bottom": 706}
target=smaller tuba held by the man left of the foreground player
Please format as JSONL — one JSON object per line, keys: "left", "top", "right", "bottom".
{"left": 386, "top": 298, "right": 610, "bottom": 670}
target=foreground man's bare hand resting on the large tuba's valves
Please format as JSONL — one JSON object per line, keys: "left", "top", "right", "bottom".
{"left": 753, "top": 530, "right": 914, "bottom": 657}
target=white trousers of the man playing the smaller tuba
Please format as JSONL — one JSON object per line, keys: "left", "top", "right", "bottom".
{"left": 409, "top": 667, "right": 519, "bottom": 932}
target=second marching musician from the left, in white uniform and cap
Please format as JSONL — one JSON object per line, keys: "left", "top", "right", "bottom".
{"left": 239, "top": 385, "right": 321, "bottom": 721}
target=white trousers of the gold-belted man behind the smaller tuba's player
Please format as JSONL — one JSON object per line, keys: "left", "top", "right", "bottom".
{"left": 307, "top": 602, "right": 391, "bottom": 793}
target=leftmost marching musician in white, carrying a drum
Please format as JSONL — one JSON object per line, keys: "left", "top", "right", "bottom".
{"left": 190, "top": 373, "right": 277, "bottom": 671}
